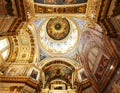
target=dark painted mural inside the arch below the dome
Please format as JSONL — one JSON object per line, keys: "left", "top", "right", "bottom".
{"left": 44, "top": 64, "right": 72, "bottom": 83}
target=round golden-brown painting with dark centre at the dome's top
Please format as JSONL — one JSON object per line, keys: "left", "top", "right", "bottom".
{"left": 46, "top": 17, "right": 70, "bottom": 40}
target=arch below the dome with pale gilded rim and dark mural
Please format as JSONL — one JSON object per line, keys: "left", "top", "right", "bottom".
{"left": 39, "top": 58, "right": 79, "bottom": 86}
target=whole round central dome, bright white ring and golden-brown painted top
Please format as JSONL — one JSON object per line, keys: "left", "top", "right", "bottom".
{"left": 40, "top": 17, "right": 79, "bottom": 55}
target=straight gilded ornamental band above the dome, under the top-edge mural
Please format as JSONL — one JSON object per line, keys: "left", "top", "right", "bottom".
{"left": 35, "top": 3, "right": 87, "bottom": 14}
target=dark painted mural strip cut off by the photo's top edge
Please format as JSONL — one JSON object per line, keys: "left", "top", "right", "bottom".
{"left": 34, "top": 0, "right": 88, "bottom": 5}
